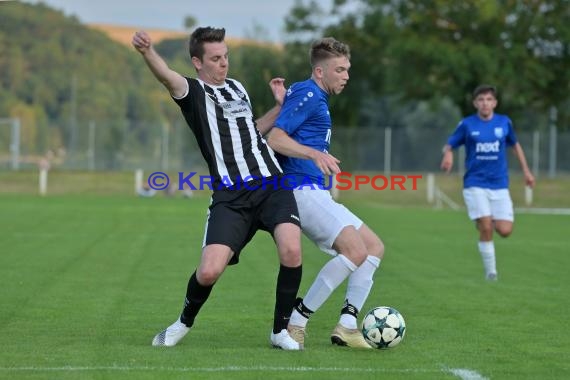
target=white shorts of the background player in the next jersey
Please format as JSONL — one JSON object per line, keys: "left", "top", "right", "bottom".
{"left": 463, "top": 187, "right": 515, "bottom": 222}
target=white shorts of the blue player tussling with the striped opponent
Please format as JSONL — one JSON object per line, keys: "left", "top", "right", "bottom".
{"left": 293, "top": 186, "right": 363, "bottom": 256}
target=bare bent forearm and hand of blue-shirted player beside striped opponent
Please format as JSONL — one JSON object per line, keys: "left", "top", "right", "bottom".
{"left": 267, "top": 128, "right": 340, "bottom": 175}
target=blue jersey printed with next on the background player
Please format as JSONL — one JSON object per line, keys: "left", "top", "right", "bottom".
{"left": 447, "top": 114, "right": 517, "bottom": 190}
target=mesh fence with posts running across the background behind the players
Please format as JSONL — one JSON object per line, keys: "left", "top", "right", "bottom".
{"left": 0, "top": 118, "right": 570, "bottom": 178}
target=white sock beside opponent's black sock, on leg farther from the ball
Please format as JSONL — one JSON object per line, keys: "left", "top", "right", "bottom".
{"left": 300, "top": 255, "right": 356, "bottom": 316}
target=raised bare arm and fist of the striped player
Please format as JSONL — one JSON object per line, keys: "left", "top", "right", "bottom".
{"left": 132, "top": 30, "right": 188, "bottom": 98}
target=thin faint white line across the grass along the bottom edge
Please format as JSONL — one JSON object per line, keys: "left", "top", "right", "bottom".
{"left": 0, "top": 366, "right": 441, "bottom": 373}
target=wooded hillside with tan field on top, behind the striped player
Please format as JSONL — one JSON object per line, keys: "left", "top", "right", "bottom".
{"left": 0, "top": 0, "right": 288, "bottom": 168}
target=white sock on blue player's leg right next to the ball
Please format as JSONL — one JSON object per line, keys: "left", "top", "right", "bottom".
{"left": 339, "top": 255, "right": 381, "bottom": 329}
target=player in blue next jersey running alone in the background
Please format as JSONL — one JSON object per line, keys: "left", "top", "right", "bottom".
{"left": 441, "top": 85, "right": 534, "bottom": 281}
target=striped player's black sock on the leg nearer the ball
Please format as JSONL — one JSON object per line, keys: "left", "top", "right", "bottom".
{"left": 273, "top": 265, "right": 303, "bottom": 334}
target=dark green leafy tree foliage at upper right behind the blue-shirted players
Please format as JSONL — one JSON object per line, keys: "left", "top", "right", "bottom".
{"left": 282, "top": 0, "right": 570, "bottom": 129}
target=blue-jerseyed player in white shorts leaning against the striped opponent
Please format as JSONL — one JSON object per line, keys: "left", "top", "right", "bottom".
{"left": 268, "top": 37, "right": 384, "bottom": 348}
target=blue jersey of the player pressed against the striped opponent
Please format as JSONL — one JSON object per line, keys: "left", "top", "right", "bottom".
{"left": 275, "top": 79, "right": 332, "bottom": 184}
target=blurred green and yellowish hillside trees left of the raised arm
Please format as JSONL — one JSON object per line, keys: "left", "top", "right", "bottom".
{"left": 0, "top": 2, "right": 168, "bottom": 158}
